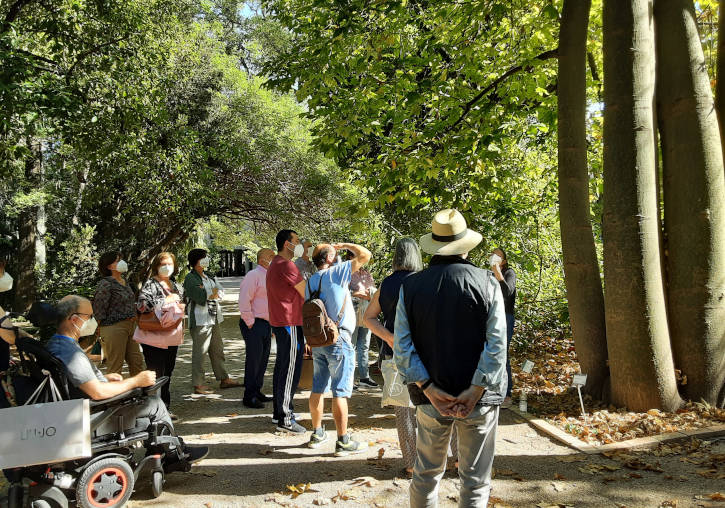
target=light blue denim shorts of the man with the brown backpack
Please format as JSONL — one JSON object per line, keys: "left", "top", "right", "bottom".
{"left": 312, "top": 332, "right": 355, "bottom": 397}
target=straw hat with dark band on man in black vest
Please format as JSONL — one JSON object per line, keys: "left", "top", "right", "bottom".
{"left": 420, "top": 208, "right": 482, "bottom": 256}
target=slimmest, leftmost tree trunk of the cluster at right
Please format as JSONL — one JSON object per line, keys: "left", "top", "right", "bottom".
{"left": 558, "top": 0, "right": 609, "bottom": 399}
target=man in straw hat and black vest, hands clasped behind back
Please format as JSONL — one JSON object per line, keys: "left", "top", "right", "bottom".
{"left": 394, "top": 209, "right": 506, "bottom": 508}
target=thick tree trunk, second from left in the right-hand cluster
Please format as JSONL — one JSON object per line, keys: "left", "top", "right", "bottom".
{"left": 603, "top": 0, "right": 681, "bottom": 411}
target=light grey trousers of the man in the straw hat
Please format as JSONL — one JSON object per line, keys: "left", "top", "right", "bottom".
{"left": 410, "top": 404, "right": 499, "bottom": 508}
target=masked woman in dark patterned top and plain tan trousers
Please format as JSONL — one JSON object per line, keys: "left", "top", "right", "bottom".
{"left": 93, "top": 252, "right": 144, "bottom": 377}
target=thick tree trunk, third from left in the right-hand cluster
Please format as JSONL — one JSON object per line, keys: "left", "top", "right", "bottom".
{"left": 655, "top": 0, "right": 725, "bottom": 404}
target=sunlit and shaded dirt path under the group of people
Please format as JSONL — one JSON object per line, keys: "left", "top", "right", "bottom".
{"left": 4, "top": 279, "right": 725, "bottom": 508}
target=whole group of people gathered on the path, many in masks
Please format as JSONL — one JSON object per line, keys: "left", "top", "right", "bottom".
{"left": 0, "top": 209, "right": 516, "bottom": 507}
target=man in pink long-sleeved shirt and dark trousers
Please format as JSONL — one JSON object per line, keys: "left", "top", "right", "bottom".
{"left": 239, "top": 249, "right": 274, "bottom": 409}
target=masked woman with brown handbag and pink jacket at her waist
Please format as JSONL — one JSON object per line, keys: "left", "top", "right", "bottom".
{"left": 134, "top": 252, "right": 184, "bottom": 414}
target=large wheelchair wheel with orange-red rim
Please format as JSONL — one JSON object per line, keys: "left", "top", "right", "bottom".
{"left": 76, "top": 457, "right": 134, "bottom": 508}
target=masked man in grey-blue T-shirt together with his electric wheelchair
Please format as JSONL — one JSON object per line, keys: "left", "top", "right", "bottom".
{"left": 0, "top": 295, "right": 209, "bottom": 508}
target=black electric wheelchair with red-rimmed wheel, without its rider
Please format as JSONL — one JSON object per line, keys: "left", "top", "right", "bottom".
{"left": 0, "top": 309, "right": 198, "bottom": 508}
